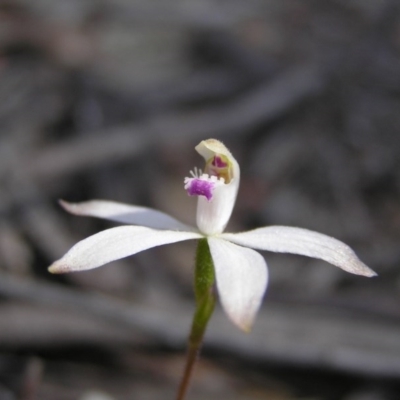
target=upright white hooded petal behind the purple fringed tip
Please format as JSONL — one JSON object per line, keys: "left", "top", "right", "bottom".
{"left": 196, "top": 139, "right": 240, "bottom": 235}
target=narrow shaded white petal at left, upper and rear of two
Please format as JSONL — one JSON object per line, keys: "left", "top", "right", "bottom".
{"left": 60, "top": 200, "right": 196, "bottom": 232}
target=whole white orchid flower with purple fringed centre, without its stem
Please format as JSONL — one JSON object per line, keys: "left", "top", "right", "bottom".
{"left": 49, "top": 139, "right": 376, "bottom": 331}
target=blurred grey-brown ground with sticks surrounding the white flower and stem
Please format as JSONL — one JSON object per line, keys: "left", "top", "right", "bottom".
{"left": 0, "top": 0, "right": 400, "bottom": 400}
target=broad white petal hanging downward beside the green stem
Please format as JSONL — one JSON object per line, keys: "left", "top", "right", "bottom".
{"left": 208, "top": 237, "right": 268, "bottom": 331}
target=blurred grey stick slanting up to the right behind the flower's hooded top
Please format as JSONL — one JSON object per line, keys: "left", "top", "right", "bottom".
{"left": 19, "top": 63, "right": 329, "bottom": 188}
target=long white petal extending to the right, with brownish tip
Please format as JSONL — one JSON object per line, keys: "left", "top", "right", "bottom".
{"left": 221, "top": 226, "right": 376, "bottom": 276}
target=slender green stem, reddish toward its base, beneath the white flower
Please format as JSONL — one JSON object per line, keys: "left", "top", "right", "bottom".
{"left": 177, "top": 239, "right": 216, "bottom": 400}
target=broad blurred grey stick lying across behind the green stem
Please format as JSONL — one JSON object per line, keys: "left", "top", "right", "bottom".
{"left": 0, "top": 272, "right": 400, "bottom": 379}
